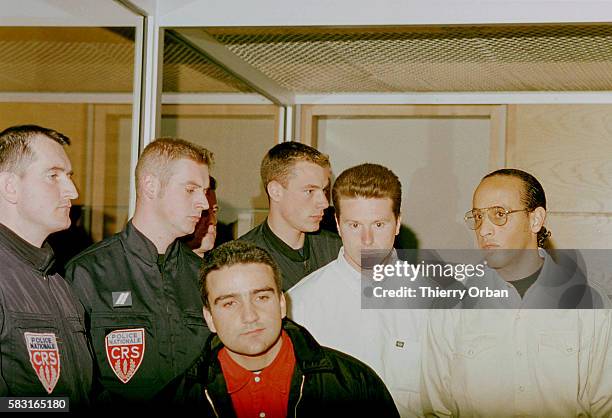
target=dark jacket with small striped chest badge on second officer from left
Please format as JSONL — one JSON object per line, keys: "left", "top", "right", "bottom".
{"left": 66, "top": 222, "right": 210, "bottom": 407}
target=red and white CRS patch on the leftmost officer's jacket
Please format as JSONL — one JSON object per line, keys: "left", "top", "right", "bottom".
{"left": 23, "top": 332, "right": 61, "bottom": 394}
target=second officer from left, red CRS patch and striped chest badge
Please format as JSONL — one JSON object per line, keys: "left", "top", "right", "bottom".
{"left": 66, "top": 138, "right": 212, "bottom": 408}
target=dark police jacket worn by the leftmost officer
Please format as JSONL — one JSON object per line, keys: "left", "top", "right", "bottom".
{"left": 0, "top": 224, "right": 93, "bottom": 410}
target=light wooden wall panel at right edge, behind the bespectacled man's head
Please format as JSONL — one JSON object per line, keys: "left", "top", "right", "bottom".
{"left": 507, "top": 105, "right": 612, "bottom": 213}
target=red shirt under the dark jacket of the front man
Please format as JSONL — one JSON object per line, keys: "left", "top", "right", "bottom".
{"left": 217, "top": 331, "right": 295, "bottom": 418}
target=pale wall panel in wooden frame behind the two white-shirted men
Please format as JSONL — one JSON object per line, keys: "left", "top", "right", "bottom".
{"left": 318, "top": 118, "right": 490, "bottom": 248}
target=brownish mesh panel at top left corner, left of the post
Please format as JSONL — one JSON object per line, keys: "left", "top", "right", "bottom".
{"left": 0, "top": 28, "right": 134, "bottom": 92}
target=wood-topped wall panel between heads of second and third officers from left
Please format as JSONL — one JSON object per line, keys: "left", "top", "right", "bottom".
{"left": 162, "top": 105, "right": 279, "bottom": 219}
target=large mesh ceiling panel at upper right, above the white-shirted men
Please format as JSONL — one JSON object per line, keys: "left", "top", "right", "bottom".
{"left": 207, "top": 25, "right": 612, "bottom": 93}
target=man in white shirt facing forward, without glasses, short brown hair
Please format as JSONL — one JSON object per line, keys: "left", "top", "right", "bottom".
{"left": 287, "top": 164, "right": 425, "bottom": 417}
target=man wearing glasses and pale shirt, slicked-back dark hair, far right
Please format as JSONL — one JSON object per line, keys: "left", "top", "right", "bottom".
{"left": 421, "top": 169, "right": 610, "bottom": 416}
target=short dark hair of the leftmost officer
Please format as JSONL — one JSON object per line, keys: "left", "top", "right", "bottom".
{"left": 0, "top": 125, "right": 70, "bottom": 175}
